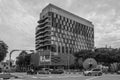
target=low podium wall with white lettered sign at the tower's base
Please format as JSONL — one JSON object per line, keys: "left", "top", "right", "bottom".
{"left": 31, "top": 51, "right": 75, "bottom": 66}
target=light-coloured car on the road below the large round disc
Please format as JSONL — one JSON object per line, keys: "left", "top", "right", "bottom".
{"left": 83, "top": 68, "right": 103, "bottom": 76}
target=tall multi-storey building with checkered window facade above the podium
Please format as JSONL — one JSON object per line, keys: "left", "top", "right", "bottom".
{"left": 33, "top": 4, "right": 94, "bottom": 67}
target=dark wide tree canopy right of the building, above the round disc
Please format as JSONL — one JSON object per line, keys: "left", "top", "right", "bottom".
{"left": 74, "top": 49, "right": 120, "bottom": 64}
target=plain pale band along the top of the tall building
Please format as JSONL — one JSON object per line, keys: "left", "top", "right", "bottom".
{"left": 41, "top": 4, "right": 94, "bottom": 27}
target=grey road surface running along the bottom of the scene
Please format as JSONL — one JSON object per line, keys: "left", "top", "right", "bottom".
{"left": 10, "top": 73, "right": 120, "bottom": 80}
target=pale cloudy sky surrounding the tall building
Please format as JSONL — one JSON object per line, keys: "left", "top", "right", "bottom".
{"left": 0, "top": 0, "right": 120, "bottom": 58}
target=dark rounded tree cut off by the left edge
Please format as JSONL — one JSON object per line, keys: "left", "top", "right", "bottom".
{"left": 0, "top": 41, "right": 8, "bottom": 62}
